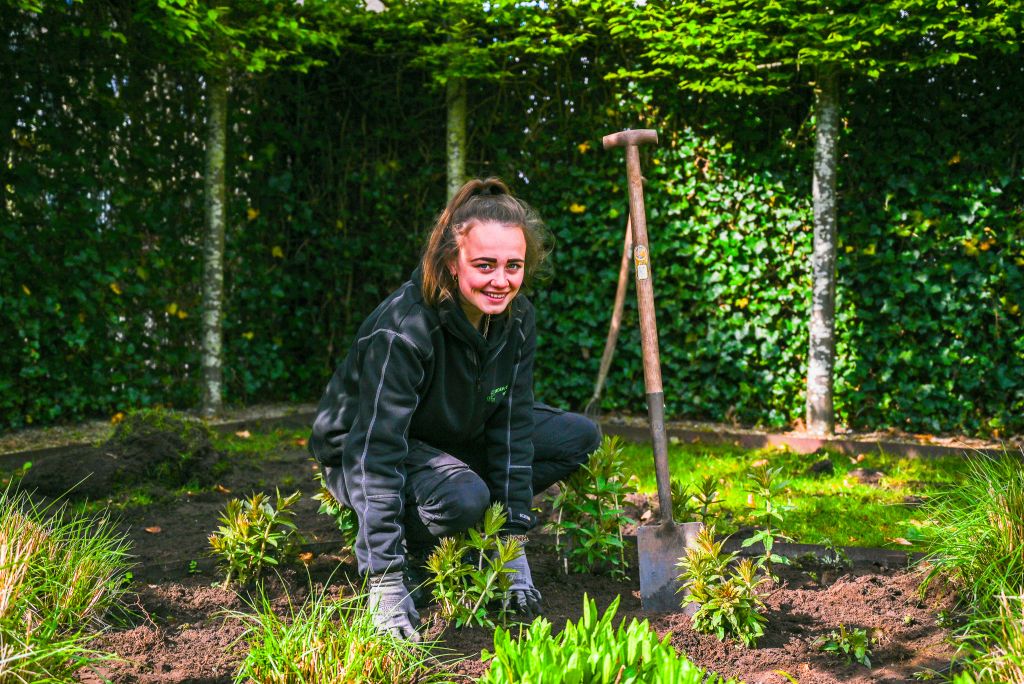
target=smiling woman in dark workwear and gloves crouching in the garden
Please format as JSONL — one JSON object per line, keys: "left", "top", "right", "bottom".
{"left": 309, "top": 178, "right": 600, "bottom": 640}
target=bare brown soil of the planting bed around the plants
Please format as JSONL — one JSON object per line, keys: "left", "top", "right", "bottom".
{"left": 0, "top": 423, "right": 953, "bottom": 684}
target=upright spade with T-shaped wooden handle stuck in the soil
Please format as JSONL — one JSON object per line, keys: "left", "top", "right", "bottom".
{"left": 602, "top": 129, "right": 701, "bottom": 613}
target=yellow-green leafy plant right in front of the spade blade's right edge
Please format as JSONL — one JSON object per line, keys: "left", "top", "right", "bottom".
{"left": 678, "top": 525, "right": 768, "bottom": 646}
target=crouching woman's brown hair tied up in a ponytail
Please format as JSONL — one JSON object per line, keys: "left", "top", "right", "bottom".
{"left": 422, "top": 178, "right": 551, "bottom": 306}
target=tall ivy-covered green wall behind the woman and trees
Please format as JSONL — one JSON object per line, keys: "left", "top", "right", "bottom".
{"left": 0, "top": 5, "right": 1024, "bottom": 433}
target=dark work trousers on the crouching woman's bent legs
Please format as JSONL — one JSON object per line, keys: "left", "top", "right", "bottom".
{"left": 325, "top": 403, "right": 601, "bottom": 556}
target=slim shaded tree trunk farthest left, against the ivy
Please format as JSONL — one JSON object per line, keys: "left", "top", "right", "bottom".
{"left": 202, "top": 73, "right": 227, "bottom": 416}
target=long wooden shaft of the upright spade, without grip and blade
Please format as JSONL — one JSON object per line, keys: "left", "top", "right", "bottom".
{"left": 626, "top": 144, "right": 674, "bottom": 524}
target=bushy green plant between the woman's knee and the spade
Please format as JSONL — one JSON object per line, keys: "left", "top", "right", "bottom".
{"left": 548, "top": 436, "right": 636, "bottom": 579}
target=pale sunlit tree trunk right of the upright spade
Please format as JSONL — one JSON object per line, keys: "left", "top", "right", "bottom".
{"left": 807, "top": 70, "right": 839, "bottom": 435}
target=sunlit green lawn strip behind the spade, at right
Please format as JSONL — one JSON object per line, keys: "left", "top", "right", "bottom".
{"left": 624, "top": 443, "right": 967, "bottom": 550}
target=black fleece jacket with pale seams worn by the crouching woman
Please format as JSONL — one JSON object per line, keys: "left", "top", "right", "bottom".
{"left": 309, "top": 270, "right": 537, "bottom": 574}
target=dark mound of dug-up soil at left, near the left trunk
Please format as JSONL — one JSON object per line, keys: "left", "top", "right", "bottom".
{"left": 22, "top": 410, "right": 220, "bottom": 499}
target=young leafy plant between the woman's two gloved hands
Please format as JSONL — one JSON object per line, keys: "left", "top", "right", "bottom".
{"left": 427, "top": 504, "right": 522, "bottom": 628}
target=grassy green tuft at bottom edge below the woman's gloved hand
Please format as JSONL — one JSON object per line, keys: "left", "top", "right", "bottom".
{"left": 227, "top": 591, "right": 453, "bottom": 684}
